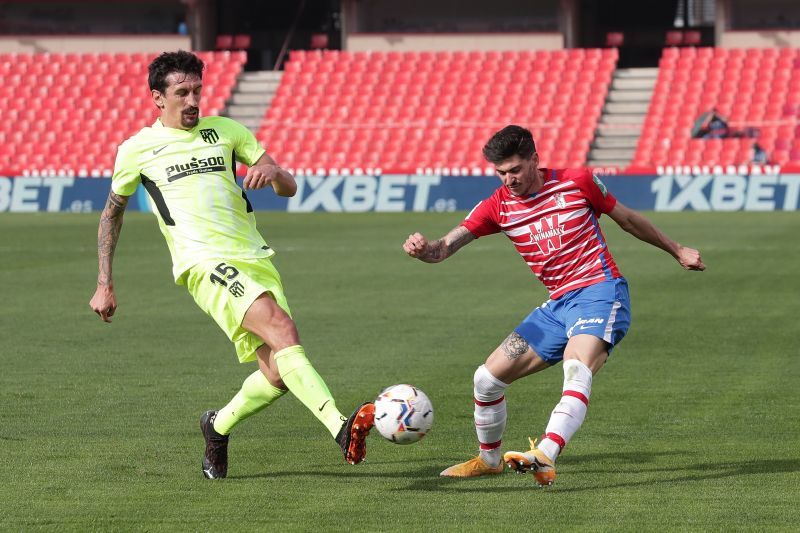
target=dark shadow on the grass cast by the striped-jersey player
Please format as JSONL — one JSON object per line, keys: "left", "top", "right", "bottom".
{"left": 397, "top": 450, "right": 800, "bottom": 493}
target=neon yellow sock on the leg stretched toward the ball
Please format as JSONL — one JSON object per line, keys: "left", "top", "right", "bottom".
{"left": 275, "top": 345, "right": 346, "bottom": 437}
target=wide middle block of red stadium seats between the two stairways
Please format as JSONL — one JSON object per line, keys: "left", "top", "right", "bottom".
{"left": 258, "top": 49, "right": 617, "bottom": 171}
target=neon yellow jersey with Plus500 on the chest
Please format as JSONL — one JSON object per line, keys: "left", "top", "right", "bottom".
{"left": 111, "top": 117, "right": 275, "bottom": 283}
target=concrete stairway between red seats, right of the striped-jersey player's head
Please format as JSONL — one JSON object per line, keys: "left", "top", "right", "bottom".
{"left": 587, "top": 68, "right": 658, "bottom": 168}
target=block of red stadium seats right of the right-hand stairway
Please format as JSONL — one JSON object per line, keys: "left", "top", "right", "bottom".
{"left": 633, "top": 48, "right": 800, "bottom": 166}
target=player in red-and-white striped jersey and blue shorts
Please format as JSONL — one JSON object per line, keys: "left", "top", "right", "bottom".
{"left": 403, "top": 125, "right": 705, "bottom": 486}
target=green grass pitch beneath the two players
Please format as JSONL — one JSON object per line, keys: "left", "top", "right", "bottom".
{"left": 0, "top": 213, "right": 800, "bottom": 531}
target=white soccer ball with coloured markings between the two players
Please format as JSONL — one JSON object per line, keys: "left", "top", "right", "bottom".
{"left": 375, "top": 385, "right": 433, "bottom": 444}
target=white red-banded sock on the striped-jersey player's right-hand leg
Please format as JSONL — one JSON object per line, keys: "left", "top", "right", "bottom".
{"left": 536, "top": 359, "right": 592, "bottom": 461}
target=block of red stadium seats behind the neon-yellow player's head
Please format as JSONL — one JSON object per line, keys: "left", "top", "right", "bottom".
{"left": 0, "top": 52, "right": 243, "bottom": 172}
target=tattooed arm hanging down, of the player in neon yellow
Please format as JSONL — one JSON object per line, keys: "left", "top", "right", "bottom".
{"left": 89, "top": 191, "right": 128, "bottom": 322}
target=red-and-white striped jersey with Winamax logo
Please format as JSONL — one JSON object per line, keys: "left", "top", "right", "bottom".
{"left": 461, "top": 168, "right": 622, "bottom": 299}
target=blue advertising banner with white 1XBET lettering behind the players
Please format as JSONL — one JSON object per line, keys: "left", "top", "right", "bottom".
{"left": 0, "top": 167, "right": 800, "bottom": 213}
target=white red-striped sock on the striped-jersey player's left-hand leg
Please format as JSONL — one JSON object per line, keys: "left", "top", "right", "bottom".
{"left": 473, "top": 365, "right": 508, "bottom": 466}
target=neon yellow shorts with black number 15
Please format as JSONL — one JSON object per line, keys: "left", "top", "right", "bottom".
{"left": 181, "top": 258, "right": 292, "bottom": 363}
